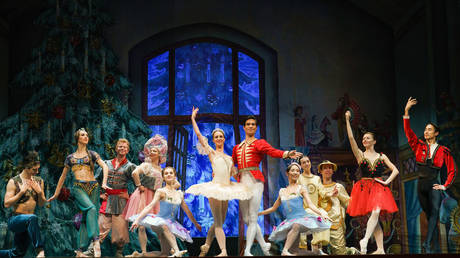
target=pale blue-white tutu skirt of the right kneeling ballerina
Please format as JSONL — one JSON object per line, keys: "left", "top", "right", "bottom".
{"left": 268, "top": 214, "right": 331, "bottom": 241}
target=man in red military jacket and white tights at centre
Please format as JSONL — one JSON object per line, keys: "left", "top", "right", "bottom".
{"left": 232, "top": 116, "right": 302, "bottom": 256}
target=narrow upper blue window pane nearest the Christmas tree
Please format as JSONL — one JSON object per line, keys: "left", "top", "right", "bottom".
{"left": 147, "top": 51, "right": 169, "bottom": 116}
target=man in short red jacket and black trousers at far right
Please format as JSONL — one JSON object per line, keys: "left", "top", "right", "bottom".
{"left": 403, "top": 97, "right": 458, "bottom": 253}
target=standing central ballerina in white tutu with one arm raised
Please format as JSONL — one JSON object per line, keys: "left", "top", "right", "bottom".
{"left": 185, "top": 107, "right": 252, "bottom": 256}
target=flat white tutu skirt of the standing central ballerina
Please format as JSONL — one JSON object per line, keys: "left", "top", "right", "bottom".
{"left": 185, "top": 181, "right": 252, "bottom": 201}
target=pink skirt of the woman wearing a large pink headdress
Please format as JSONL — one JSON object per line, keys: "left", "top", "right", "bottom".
{"left": 123, "top": 188, "right": 160, "bottom": 220}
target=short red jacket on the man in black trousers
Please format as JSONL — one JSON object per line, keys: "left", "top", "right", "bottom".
{"left": 404, "top": 118, "right": 458, "bottom": 188}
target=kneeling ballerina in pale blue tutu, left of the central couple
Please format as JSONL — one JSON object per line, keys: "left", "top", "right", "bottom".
{"left": 129, "top": 167, "right": 201, "bottom": 257}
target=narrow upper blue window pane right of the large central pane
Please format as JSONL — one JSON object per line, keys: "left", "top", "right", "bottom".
{"left": 238, "top": 52, "right": 260, "bottom": 115}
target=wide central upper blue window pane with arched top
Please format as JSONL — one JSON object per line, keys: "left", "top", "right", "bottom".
{"left": 175, "top": 43, "right": 233, "bottom": 115}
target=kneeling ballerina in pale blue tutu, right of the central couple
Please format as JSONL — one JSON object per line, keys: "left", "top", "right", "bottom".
{"left": 259, "top": 163, "right": 331, "bottom": 256}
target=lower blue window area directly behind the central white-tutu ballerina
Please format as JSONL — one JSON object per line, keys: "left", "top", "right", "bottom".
{"left": 183, "top": 123, "right": 238, "bottom": 237}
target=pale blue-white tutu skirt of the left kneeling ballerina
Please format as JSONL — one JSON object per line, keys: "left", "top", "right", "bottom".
{"left": 129, "top": 213, "right": 193, "bottom": 243}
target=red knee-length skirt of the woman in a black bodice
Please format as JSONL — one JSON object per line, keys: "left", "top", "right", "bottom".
{"left": 347, "top": 178, "right": 398, "bottom": 217}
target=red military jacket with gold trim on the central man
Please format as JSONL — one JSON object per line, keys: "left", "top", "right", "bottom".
{"left": 232, "top": 139, "right": 284, "bottom": 182}
